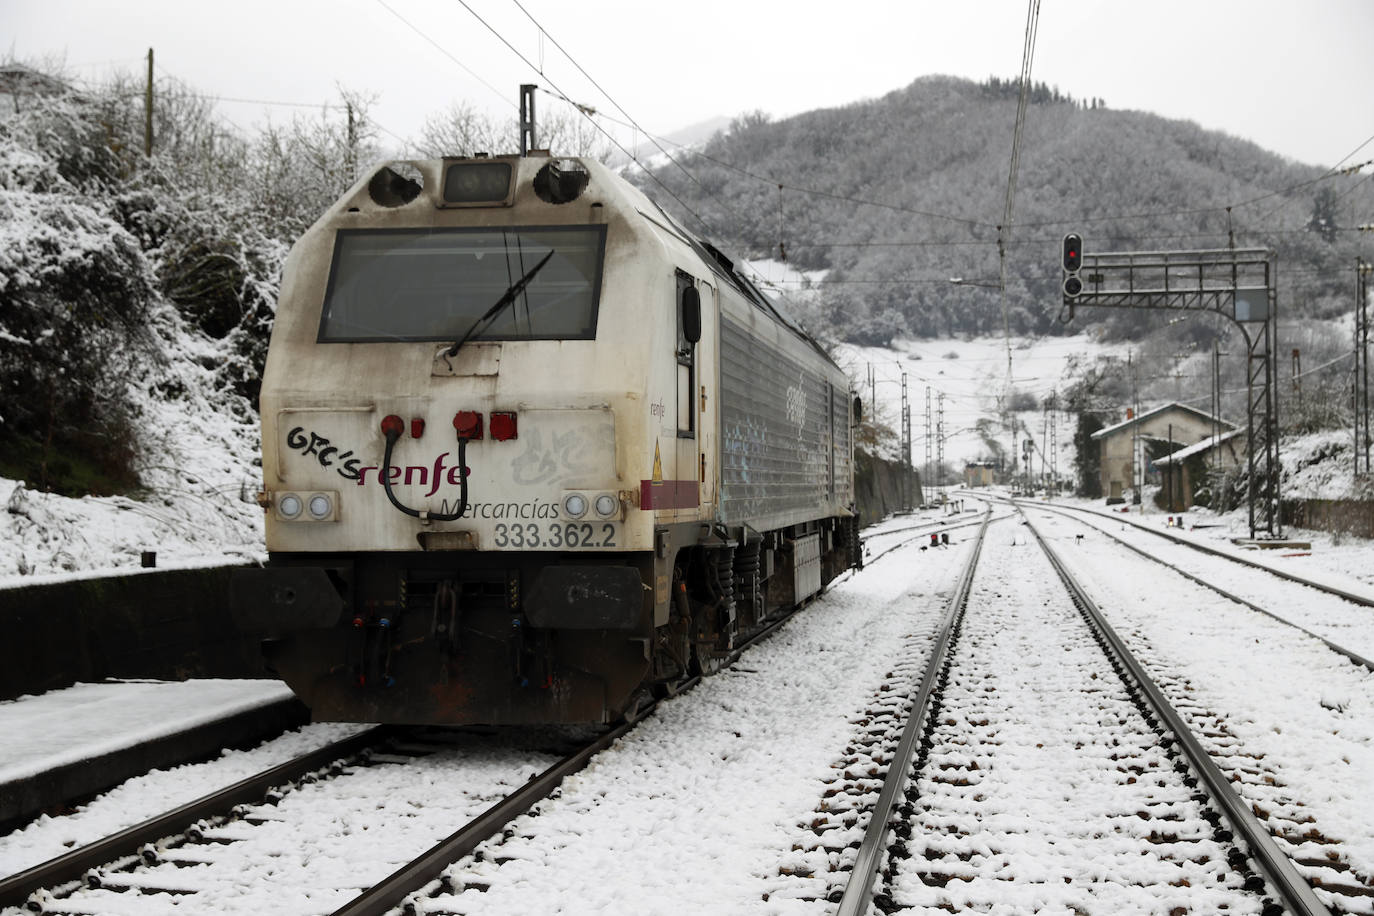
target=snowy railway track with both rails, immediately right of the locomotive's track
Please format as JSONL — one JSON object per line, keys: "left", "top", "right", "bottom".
{"left": 802, "top": 513, "right": 1367, "bottom": 915}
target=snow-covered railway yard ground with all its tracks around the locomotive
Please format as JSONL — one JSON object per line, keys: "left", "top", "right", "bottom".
{"left": 0, "top": 497, "right": 1374, "bottom": 916}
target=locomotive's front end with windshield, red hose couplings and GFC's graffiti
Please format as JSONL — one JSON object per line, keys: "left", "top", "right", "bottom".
{"left": 231, "top": 157, "right": 654, "bottom": 724}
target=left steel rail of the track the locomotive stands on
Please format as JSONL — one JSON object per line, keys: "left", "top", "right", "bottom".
{"left": 0, "top": 725, "right": 394, "bottom": 906}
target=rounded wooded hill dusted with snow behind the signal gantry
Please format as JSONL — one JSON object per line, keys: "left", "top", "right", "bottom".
{"left": 643, "top": 77, "right": 1371, "bottom": 345}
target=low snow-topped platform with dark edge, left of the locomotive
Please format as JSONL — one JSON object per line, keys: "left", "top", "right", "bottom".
{"left": 0, "top": 680, "right": 309, "bottom": 829}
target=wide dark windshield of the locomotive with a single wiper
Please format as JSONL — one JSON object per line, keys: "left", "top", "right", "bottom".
{"left": 319, "top": 225, "right": 606, "bottom": 342}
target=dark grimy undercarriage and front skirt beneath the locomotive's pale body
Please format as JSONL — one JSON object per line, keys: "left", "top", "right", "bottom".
{"left": 232, "top": 522, "right": 857, "bottom": 724}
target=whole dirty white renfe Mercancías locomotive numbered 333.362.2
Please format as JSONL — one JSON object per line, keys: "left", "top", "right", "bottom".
{"left": 231, "top": 154, "right": 859, "bottom": 724}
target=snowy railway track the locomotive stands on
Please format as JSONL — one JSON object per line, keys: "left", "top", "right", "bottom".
{"left": 0, "top": 574, "right": 824, "bottom": 916}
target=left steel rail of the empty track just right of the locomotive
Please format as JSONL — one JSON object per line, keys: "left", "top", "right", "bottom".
{"left": 835, "top": 508, "right": 992, "bottom": 916}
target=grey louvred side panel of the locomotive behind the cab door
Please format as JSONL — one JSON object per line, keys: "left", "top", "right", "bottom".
{"left": 720, "top": 312, "right": 848, "bottom": 527}
